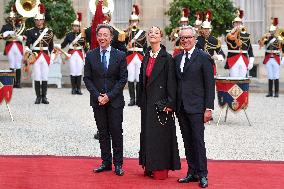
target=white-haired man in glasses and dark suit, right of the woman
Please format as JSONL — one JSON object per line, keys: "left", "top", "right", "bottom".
{"left": 175, "top": 26, "right": 215, "bottom": 188}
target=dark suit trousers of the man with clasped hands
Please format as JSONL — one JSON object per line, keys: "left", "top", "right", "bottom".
{"left": 93, "top": 104, "right": 123, "bottom": 165}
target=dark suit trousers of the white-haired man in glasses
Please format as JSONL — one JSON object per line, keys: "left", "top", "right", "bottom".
{"left": 177, "top": 107, "right": 208, "bottom": 177}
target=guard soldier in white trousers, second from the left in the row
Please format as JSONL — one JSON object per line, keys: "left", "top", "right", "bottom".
{"left": 26, "top": 4, "right": 53, "bottom": 104}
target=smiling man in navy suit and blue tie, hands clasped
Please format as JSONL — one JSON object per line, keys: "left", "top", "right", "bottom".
{"left": 84, "top": 24, "right": 127, "bottom": 176}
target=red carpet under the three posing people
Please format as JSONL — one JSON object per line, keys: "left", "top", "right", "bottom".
{"left": 0, "top": 156, "right": 284, "bottom": 189}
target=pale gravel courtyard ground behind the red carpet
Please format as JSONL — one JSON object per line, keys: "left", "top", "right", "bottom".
{"left": 0, "top": 88, "right": 284, "bottom": 161}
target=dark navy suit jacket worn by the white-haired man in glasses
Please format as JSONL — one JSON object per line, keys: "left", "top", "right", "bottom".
{"left": 174, "top": 47, "right": 215, "bottom": 113}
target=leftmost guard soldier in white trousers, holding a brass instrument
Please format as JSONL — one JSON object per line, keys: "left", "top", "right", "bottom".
{"left": 0, "top": 11, "right": 25, "bottom": 88}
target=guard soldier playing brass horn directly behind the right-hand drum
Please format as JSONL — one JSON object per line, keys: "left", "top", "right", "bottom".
{"left": 225, "top": 9, "right": 254, "bottom": 77}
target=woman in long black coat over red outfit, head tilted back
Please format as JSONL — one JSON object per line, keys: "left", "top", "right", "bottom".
{"left": 139, "top": 26, "right": 180, "bottom": 179}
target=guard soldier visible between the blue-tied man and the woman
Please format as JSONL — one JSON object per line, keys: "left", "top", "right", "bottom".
{"left": 126, "top": 5, "right": 147, "bottom": 106}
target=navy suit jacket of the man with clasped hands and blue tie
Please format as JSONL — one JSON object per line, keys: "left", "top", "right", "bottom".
{"left": 84, "top": 47, "right": 127, "bottom": 108}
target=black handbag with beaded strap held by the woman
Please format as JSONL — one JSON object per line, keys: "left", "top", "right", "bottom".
{"left": 155, "top": 99, "right": 175, "bottom": 126}
